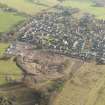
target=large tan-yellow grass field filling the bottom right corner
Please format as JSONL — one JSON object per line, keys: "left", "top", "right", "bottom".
{"left": 54, "top": 63, "right": 105, "bottom": 105}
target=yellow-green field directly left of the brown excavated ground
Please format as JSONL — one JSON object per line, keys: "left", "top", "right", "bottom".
{"left": 0, "top": 60, "right": 22, "bottom": 85}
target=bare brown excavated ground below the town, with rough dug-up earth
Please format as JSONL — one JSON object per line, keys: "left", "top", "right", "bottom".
{"left": 17, "top": 50, "right": 83, "bottom": 88}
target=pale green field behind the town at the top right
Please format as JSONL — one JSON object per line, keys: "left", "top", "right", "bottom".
{"left": 64, "top": 0, "right": 105, "bottom": 19}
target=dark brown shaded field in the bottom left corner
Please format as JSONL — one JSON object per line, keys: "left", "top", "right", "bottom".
{"left": 0, "top": 84, "right": 38, "bottom": 105}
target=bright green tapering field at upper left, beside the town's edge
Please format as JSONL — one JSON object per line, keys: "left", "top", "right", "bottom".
{"left": 0, "top": 12, "right": 25, "bottom": 32}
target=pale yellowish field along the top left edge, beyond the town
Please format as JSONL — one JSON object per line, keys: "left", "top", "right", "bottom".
{"left": 0, "top": 0, "right": 57, "bottom": 15}
